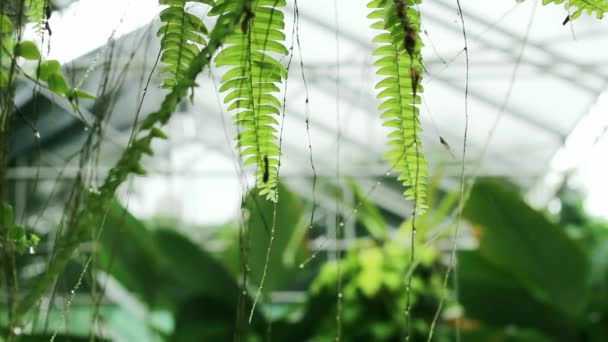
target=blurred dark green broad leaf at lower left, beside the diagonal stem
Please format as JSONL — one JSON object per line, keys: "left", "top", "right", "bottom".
{"left": 100, "top": 202, "right": 265, "bottom": 341}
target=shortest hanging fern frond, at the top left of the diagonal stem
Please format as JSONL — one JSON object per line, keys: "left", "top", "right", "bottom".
{"left": 156, "top": 0, "right": 212, "bottom": 89}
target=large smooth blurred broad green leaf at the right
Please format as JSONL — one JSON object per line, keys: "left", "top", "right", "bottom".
{"left": 464, "top": 179, "right": 590, "bottom": 316}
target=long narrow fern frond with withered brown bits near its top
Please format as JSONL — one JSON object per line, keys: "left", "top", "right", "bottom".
{"left": 368, "top": 0, "right": 428, "bottom": 214}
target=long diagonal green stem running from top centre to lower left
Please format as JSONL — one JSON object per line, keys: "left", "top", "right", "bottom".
{"left": 13, "top": 1, "right": 245, "bottom": 325}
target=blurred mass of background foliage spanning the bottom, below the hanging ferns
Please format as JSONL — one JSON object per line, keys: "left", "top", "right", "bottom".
{"left": 2, "top": 179, "right": 608, "bottom": 341}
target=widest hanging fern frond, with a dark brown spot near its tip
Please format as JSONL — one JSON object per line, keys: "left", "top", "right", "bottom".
{"left": 214, "top": 0, "right": 288, "bottom": 200}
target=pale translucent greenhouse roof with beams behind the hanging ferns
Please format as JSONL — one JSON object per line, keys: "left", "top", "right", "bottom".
{"left": 12, "top": 0, "right": 608, "bottom": 223}
